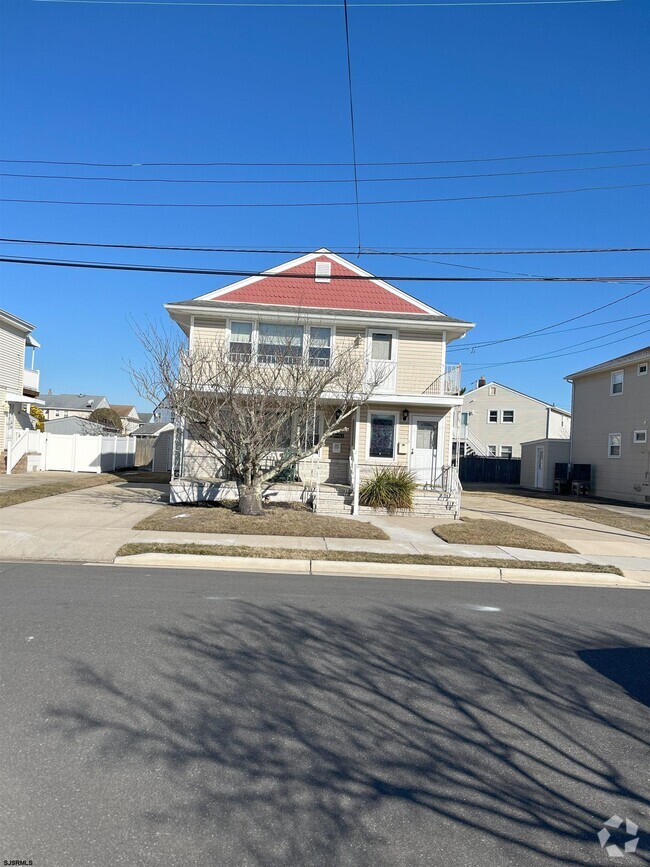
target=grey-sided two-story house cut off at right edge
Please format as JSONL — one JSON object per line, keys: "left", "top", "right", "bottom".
{"left": 566, "top": 346, "right": 650, "bottom": 503}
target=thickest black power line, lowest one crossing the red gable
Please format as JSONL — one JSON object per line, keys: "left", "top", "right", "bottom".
{"left": 0, "top": 256, "right": 650, "bottom": 282}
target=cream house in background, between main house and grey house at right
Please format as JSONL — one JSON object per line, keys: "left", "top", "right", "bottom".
{"left": 456, "top": 378, "right": 571, "bottom": 458}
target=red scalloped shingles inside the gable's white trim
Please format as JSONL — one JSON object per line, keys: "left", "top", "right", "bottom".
{"left": 210, "top": 256, "right": 426, "bottom": 313}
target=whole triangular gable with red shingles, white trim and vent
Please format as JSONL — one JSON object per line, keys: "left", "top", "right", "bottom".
{"left": 196, "top": 250, "right": 442, "bottom": 316}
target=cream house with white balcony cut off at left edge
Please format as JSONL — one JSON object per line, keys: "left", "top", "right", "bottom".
{"left": 0, "top": 310, "right": 42, "bottom": 469}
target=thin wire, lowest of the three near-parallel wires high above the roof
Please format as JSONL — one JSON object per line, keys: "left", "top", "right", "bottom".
{"left": 0, "top": 182, "right": 650, "bottom": 208}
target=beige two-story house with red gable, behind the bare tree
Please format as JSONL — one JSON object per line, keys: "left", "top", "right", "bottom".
{"left": 165, "top": 249, "right": 473, "bottom": 512}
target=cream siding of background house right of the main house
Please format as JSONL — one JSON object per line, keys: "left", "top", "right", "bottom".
{"left": 462, "top": 383, "right": 564, "bottom": 458}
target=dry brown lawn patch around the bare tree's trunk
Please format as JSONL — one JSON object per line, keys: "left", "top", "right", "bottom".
{"left": 134, "top": 504, "right": 388, "bottom": 539}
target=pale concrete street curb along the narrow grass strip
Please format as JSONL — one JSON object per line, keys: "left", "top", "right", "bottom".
{"left": 113, "top": 552, "right": 650, "bottom": 590}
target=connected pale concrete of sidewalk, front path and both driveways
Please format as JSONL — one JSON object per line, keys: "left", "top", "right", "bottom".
{"left": 0, "top": 474, "right": 650, "bottom": 578}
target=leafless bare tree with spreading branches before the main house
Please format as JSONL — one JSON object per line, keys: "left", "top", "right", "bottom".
{"left": 129, "top": 320, "right": 387, "bottom": 515}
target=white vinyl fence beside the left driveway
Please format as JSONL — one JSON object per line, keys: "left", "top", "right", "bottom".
{"left": 7, "top": 431, "right": 136, "bottom": 473}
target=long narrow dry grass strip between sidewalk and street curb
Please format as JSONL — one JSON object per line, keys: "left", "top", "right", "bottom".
{"left": 116, "top": 542, "right": 623, "bottom": 575}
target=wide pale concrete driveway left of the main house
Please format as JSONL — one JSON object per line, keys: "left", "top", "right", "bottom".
{"left": 0, "top": 482, "right": 169, "bottom": 562}
